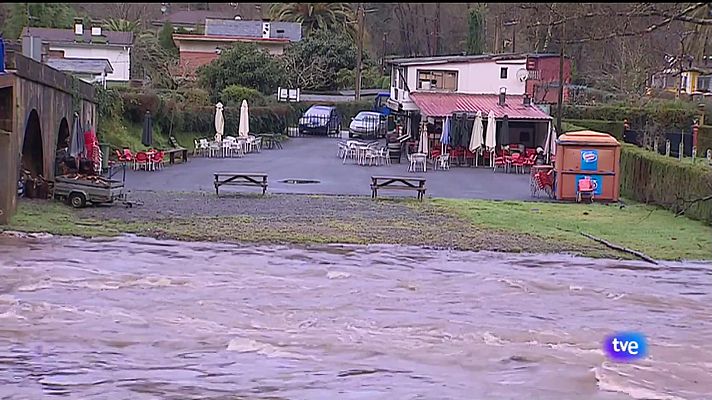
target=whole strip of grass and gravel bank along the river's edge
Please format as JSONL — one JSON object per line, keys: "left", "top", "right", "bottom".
{"left": 8, "top": 192, "right": 712, "bottom": 260}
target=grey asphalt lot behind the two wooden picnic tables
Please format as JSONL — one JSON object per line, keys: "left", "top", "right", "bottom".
{"left": 126, "top": 137, "right": 531, "bottom": 200}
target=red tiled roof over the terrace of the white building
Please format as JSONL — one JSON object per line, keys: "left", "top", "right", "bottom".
{"left": 410, "top": 92, "right": 551, "bottom": 119}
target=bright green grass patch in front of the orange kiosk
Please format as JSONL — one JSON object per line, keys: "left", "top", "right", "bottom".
{"left": 433, "top": 199, "right": 712, "bottom": 260}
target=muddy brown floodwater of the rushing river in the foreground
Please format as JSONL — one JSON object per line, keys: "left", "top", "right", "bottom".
{"left": 0, "top": 236, "right": 712, "bottom": 400}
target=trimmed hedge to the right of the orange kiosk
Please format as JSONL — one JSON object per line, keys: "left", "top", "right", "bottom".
{"left": 620, "top": 144, "right": 712, "bottom": 225}
